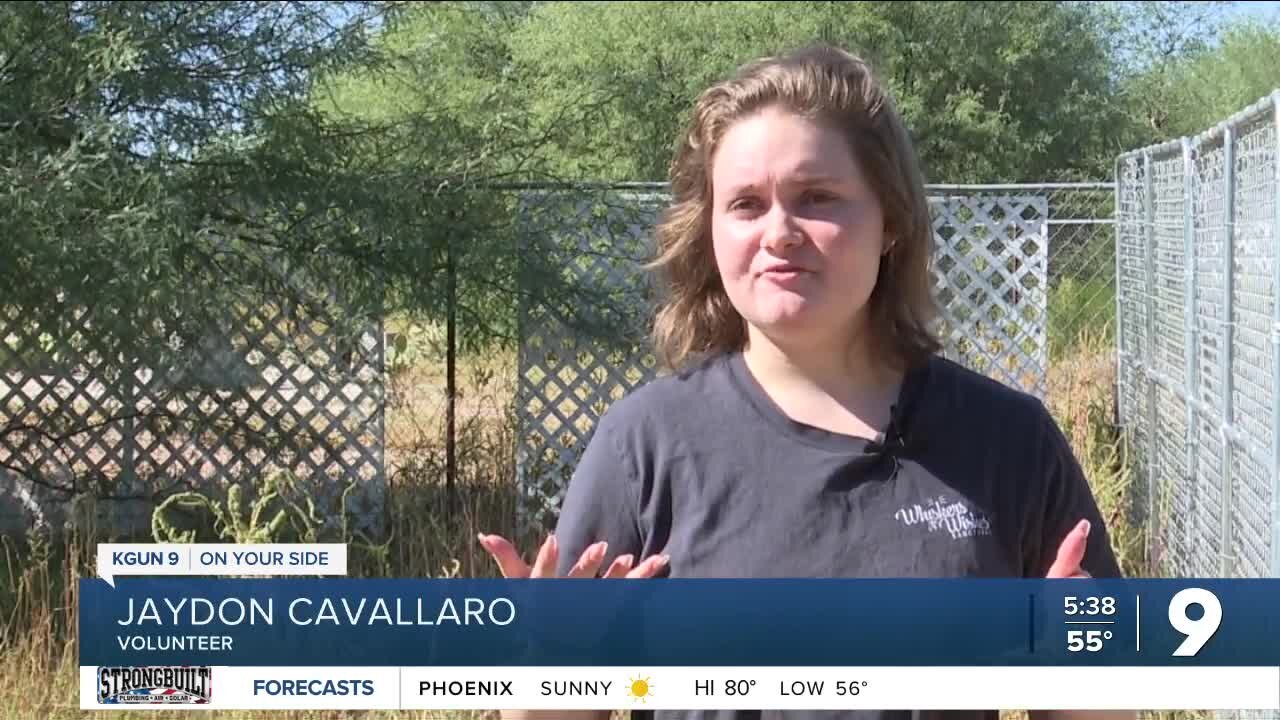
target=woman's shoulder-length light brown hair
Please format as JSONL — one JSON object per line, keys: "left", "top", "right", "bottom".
{"left": 650, "top": 46, "right": 940, "bottom": 368}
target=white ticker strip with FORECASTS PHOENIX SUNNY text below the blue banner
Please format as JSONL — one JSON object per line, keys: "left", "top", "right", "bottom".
{"left": 81, "top": 666, "right": 1280, "bottom": 711}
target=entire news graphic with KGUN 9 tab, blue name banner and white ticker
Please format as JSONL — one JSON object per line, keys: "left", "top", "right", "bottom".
{"left": 79, "top": 544, "right": 1280, "bottom": 712}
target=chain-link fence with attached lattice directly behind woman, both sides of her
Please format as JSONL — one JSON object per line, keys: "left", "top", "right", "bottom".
{"left": 516, "top": 183, "right": 1115, "bottom": 527}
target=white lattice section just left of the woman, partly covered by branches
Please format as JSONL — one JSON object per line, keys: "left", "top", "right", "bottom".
{"left": 516, "top": 193, "right": 663, "bottom": 524}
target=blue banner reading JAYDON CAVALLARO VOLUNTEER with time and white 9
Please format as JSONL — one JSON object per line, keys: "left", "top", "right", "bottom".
{"left": 79, "top": 578, "right": 1280, "bottom": 666}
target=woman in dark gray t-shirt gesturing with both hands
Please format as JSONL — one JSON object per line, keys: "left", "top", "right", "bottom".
{"left": 480, "top": 47, "right": 1132, "bottom": 719}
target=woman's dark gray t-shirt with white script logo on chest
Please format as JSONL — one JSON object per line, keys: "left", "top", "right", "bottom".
{"left": 556, "top": 352, "right": 1120, "bottom": 720}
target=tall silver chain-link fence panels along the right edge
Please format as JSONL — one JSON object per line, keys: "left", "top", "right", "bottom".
{"left": 1116, "top": 91, "right": 1280, "bottom": 577}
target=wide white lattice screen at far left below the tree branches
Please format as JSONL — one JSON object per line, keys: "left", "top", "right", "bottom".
{"left": 0, "top": 272, "right": 385, "bottom": 532}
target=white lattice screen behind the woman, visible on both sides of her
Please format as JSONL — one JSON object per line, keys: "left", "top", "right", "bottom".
{"left": 516, "top": 193, "right": 1048, "bottom": 527}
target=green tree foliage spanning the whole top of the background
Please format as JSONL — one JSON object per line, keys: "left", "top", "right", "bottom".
{"left": 0, "top": 1, "right": 1259, "bottom": 381}
